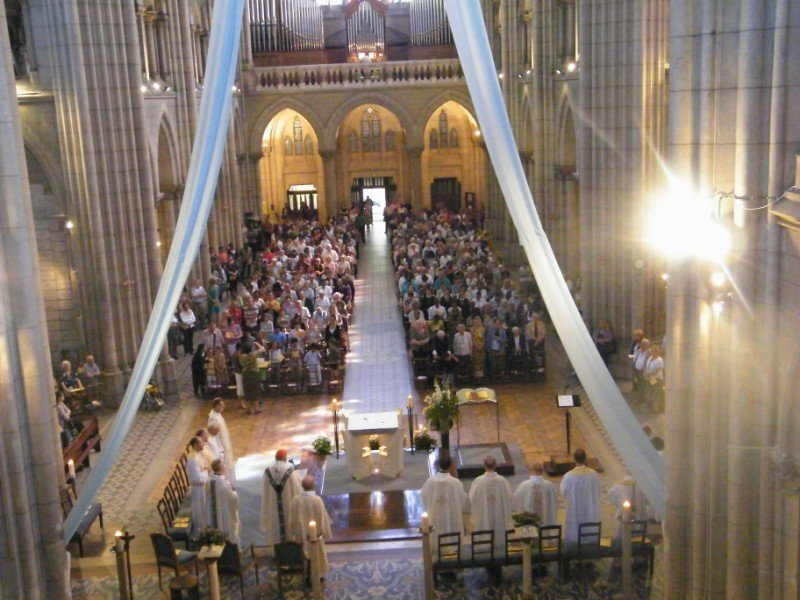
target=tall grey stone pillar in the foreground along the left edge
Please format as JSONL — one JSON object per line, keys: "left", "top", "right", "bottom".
{"left": 0, "top": 5, "right": 70, "bottom": 600}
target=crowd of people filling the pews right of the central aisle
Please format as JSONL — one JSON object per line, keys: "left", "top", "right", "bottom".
{"left": 387, "top": 205, "right": 547, "bottom": 383}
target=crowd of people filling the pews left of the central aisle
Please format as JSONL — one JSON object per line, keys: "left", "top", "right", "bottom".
{"left": 175, "top": 214, "right": 358, "bottom": 412}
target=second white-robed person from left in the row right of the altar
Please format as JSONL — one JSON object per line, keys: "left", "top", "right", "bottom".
{"left": 469, "top": 455, "right": 514, "bottom": 549}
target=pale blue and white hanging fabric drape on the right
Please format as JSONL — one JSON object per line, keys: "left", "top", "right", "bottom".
{"left": 445, "top": 0, "right": 665, "bottom": 514}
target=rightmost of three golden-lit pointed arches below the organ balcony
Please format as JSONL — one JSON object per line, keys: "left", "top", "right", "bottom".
{"left": 421, "top": 99, "right": 486, "bottom": 212}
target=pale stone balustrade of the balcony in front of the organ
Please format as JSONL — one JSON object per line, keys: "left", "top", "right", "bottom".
{"left": 250, "top": 59, "right": 464, "bottom": 92}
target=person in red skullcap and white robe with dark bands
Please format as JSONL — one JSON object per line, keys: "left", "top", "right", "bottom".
{"left": 261, "top": 450, "right": 303, "bottom": 546}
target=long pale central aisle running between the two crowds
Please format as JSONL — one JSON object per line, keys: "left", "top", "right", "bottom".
{"left": 343, "top": 229, "right": 413, "bottom": 413}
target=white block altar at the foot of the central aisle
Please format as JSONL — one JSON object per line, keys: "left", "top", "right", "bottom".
{"left": 344, "top": 412, "right": 405, "bottom": 480}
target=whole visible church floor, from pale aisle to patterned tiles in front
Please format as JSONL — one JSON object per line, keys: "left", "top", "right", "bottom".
{"left": 67, "top": 226, "right": 658, "bottom": 598}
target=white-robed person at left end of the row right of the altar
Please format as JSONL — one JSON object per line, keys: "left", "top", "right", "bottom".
{"left": 421, "top": 456, "right": 469, "bottom": 548}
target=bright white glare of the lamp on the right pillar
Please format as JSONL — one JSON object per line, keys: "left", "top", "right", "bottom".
{"left": 647, "top": 188, "right": 731, "bottom": 262}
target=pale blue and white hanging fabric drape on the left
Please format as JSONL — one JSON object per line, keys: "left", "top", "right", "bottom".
{"left": 64, "top": 0, "right": 244, "bottom": 543}
